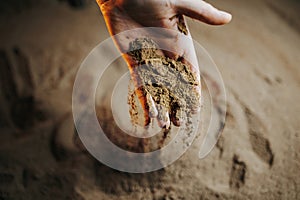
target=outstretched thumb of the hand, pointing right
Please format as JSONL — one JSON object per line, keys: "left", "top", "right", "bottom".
{"left": 173, "top": 0, "right": 232, "bottom": 25}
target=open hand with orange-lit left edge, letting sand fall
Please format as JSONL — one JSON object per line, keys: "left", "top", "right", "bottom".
{"left": 97, "top": 0, "right": 231, "bottom": 127}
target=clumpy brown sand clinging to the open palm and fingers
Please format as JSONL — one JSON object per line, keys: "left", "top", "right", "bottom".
{"left": 128, "top": 38, "right": 200, "bottom": 132}
